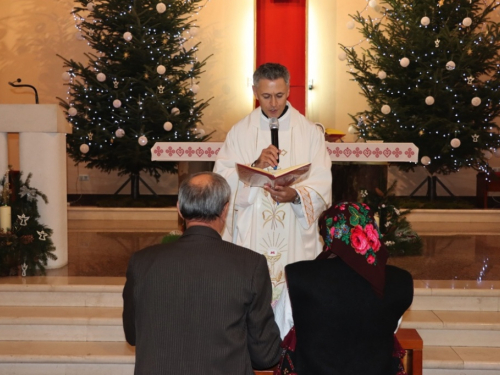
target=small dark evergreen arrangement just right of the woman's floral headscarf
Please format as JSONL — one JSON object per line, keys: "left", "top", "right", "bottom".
{"left": 363, "top": 181, "right": 423, "bottom": 256}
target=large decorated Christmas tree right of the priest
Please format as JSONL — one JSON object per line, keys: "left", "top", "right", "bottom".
{"left": 339, "top": 0, "right": 500, "bottom": 174}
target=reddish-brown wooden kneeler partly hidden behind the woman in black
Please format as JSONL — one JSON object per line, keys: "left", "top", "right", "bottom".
{"left": 254, "top": 328, "right": 424, "bottom": 375}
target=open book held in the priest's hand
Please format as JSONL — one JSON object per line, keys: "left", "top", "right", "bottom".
{"left": 236, "top": 163, "right": 311, "bottom": 187}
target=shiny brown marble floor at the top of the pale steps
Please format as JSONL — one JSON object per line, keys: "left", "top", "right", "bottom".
{"left": 47, "top": 229, "right": 500, "bottom": 281}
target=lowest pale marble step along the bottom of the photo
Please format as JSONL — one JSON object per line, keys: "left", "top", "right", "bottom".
{"left": 0, "top": 341, "right": 500, "bottom": 375}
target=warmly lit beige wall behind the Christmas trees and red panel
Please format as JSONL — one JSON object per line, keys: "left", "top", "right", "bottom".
{"left": 0, "top": 0, "right": 500, "bottom": 195}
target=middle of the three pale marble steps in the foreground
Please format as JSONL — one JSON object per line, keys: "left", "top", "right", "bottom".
{"left": 0, "top": 306, "right": 500, "bottom": 347}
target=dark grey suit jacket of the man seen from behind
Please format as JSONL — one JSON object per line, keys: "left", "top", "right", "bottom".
{"left": 123, "top": 226, "right": 280, "bottom": 375}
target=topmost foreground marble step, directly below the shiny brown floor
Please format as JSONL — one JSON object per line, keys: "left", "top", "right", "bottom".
{"left": 0, "top": 276, "right": 500, "bottom": 311}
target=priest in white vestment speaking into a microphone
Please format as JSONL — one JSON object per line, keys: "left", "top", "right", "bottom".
{"left": 214, "top": 63, "right": 332, "bottom": 303}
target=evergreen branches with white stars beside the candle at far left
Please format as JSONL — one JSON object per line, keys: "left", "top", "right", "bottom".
{"left": 0, "top": 173, "right": 57, "bottom": 276}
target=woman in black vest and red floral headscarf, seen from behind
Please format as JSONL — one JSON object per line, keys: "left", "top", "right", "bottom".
{"left": 275, "top": 202, "right": 413, "bottom": 375}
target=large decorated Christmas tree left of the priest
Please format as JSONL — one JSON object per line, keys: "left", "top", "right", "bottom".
{"left": 59, "top": 0, "right": 210, "bottom": 198}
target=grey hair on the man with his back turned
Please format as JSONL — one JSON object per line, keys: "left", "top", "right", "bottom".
{"left": 178, "top": 172, "right": 231, "bottom": 222}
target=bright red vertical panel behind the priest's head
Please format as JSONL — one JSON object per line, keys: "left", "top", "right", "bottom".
{"left": 256, "top": 0, "right": 307, "bottom": 114}
